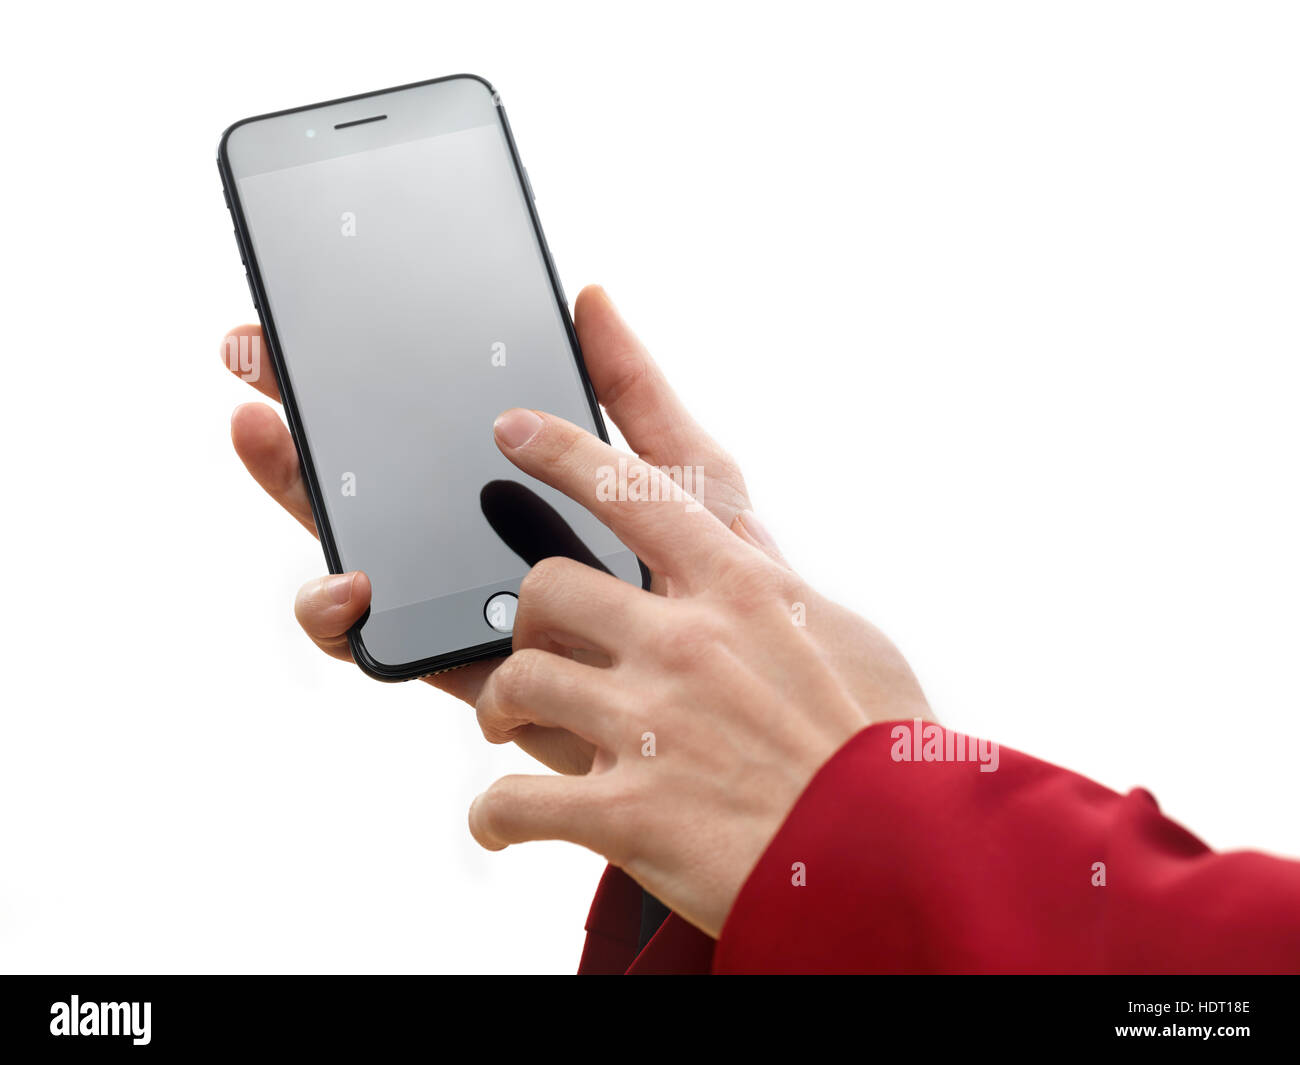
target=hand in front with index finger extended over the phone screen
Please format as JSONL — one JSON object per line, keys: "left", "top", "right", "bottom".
{"left": 469, "top": 410, "right": 930, "bottom": 936}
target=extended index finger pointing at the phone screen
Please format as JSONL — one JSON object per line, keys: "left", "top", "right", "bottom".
{"left": 493, "top": 407, "right": 740, "bottom": 581}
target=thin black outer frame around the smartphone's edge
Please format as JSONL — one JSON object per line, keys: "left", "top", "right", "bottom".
{"left": 217, "top": 74, "right": 650, "bottom": 681}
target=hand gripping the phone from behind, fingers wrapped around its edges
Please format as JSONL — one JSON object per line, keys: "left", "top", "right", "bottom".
{"left": 222, "top": 286, "right": 776, "bottom": 772}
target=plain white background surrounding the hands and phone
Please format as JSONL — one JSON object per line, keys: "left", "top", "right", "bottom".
{"left": 0, "top": 0, "right": 1300, "bottom": 971}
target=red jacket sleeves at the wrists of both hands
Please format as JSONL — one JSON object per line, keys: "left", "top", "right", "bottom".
{"left": 579, "top": 723, "right": 1300, "bottom": 974}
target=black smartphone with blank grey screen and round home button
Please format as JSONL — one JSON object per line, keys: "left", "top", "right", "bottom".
{"left": 217, "top": 74, "right": 649, "bottom": 680}
